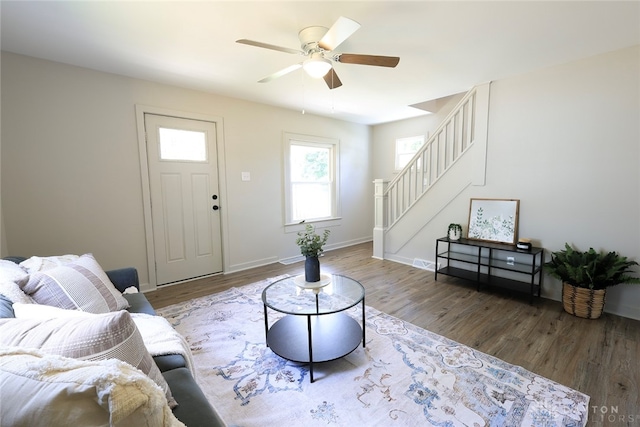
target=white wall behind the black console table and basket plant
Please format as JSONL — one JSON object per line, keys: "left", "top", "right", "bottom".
{"left": 373, "top": 46, "right": 640, "bottom": 319}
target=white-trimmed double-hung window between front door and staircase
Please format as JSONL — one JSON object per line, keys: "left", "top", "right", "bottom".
{"left": 284, "top": 134, "right": 338, "bottom": 224}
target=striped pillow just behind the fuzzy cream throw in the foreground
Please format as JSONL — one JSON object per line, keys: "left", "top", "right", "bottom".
{"left": 0, "top": 310, "right": 176, "bottom": 407}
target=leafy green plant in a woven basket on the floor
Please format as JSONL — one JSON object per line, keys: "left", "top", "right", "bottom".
{"left": 544, "top": 243, "right": 640, "bottom": 319}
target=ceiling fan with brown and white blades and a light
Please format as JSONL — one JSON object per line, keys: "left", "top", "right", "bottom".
{"left": 236, "top": 16, "right": 400, "bottom": 89}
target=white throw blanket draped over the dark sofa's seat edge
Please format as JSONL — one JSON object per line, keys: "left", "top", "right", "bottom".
{"left": 131, "top": 313, "right": 196, "bottom": 379}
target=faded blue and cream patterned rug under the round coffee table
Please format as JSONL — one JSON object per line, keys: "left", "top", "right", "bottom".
{"left": 158, "top": 278, "right": 589, "bottom": 427}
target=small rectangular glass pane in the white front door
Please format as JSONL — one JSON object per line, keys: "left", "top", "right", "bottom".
{"left": 160, "top": 128, "right": 207, "bottom": 162}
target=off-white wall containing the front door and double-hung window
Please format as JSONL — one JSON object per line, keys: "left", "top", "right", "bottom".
{"left": 1, "top": 52, "right": 373, "bottom": 283}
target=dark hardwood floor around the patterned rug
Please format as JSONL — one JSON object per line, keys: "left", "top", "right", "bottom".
{"left": 146, "top": 243, "right": 640, "bottom": 426}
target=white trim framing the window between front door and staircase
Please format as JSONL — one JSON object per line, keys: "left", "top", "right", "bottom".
{"left": 283, "top": 132, "right": 342, "bottom": 233}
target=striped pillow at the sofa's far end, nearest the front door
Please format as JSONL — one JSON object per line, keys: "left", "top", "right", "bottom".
{"left": 19, "top": 254, "right": 129, "bottom": 313}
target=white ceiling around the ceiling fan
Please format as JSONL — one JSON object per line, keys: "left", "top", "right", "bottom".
{"left": 0, "top": 0, "right": 640, "bottom": 124}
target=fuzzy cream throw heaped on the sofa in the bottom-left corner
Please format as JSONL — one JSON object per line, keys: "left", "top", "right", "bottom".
{"left": 0, "top": 347, "right": 184, "bottom": 427}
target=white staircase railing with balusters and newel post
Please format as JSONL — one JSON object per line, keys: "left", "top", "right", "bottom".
{"left": 373, "top": 83, "right": 490, "bottom": 259}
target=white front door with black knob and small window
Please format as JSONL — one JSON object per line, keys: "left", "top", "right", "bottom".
{"left": 144, "top": 113, "right": 222, "bottom": 285}
